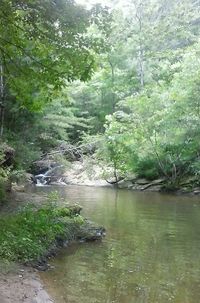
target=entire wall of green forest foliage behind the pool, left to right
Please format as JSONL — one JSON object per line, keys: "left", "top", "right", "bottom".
{"left": 0, "top": 0, "right": 200, "bottom": 191}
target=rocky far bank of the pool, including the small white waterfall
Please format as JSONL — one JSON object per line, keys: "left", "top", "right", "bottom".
{"left": 29, "top": 157, "right": 200, "bottom": 195}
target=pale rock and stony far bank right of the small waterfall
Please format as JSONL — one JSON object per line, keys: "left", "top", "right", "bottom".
{"left": 31, "top": 158, "right": 200, "bottom": 195}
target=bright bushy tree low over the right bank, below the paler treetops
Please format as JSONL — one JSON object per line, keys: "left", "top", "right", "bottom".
{"left": 106, "top": 39, "right": 200, "bottom": 183}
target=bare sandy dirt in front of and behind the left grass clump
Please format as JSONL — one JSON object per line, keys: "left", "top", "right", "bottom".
{"left": 0, "top": 191, "right": 53, "bottom": 303}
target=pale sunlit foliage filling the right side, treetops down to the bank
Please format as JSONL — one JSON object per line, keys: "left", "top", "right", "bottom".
{"left": 78, "top": 0, "right": 200, "bottom": 187}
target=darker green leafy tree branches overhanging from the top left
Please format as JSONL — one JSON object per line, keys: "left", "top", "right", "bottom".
{"left": 0, "top": 0, "right": 109, "bottom": 135}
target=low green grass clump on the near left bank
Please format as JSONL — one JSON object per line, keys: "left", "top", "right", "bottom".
{"left": 0, "top": 205, "right": 83, "bottom": 262}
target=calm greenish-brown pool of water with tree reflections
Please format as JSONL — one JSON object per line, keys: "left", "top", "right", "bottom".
{"left": 38, "top": 186, "right": 200, "bottom": 303}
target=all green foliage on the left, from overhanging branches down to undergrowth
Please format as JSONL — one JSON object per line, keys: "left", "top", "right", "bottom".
{"left": 0, "top": 0, "right": 109, "bottom": 190}
